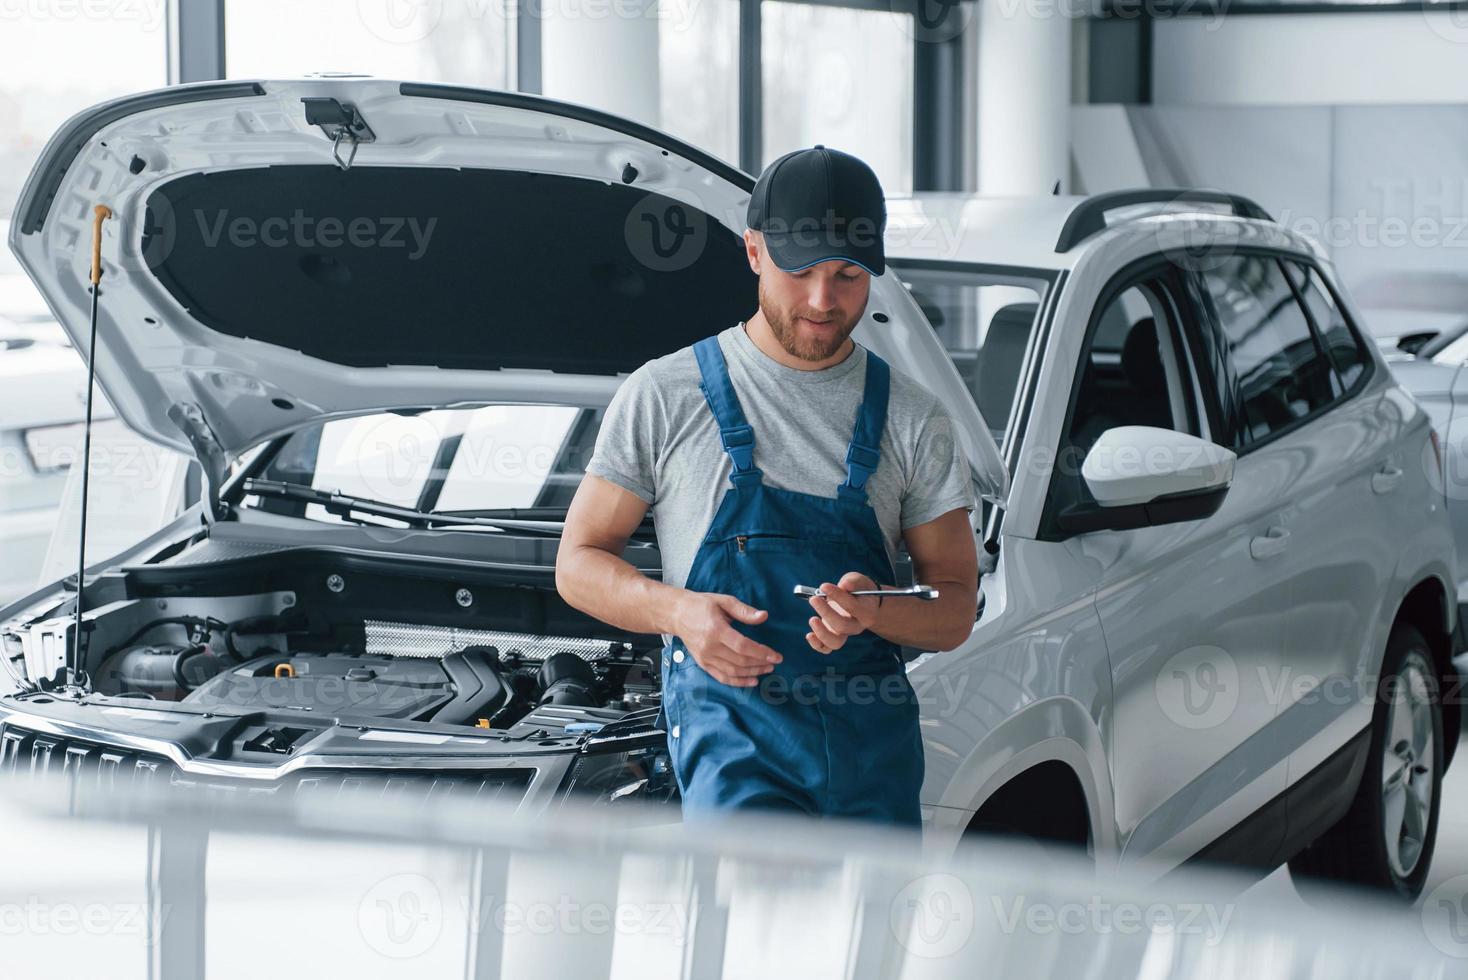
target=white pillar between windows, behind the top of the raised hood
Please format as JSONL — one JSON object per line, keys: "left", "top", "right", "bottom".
{"left": 531, "top": 0, "right": 658, "bottom": 126}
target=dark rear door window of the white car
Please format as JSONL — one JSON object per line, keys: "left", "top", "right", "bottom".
{"left": 1201, "top": 254, "right": 1337, "bottom": 449}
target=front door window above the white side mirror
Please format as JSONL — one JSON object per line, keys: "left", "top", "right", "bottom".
{"left": 1067, "top": 273, "right": 1202, "bottom": 456}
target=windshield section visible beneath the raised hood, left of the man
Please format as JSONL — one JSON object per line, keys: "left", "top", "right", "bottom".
{"left": 244, "top": 405, "right": 602, "bottom": 525}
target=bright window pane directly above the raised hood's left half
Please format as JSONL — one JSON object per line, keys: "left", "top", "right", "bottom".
{"left": 225, "top": 0, "right": 514, "bottom": 88}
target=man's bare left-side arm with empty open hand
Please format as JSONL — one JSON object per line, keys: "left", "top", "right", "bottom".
{"left": 555, "top": 474, "right": 781, "bottom": 687}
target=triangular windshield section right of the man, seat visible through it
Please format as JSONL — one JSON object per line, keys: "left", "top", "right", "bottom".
{"left": 893, "top": 261, "right": 1048, "bottom": 446}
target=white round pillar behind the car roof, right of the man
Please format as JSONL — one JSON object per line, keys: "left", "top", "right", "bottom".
{"left": 978, "top": 0, "right": 1072, "bottom": 194}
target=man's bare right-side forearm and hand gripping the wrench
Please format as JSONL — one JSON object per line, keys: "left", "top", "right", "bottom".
{"left": 806, "top": 508, "right": 979, "bottom": 653}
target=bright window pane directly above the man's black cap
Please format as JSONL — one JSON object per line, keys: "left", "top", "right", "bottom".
{"left": 760, "top": 0, "right": 913, "bottom": 195}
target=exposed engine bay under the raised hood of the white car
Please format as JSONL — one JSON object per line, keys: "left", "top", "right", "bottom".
{"left": 0, "top": 538, "right": 672, "bottom": 748}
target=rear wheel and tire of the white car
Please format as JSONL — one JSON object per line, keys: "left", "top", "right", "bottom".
{"left": 1289, "top": 624, "right": 1438, "bottom": 902}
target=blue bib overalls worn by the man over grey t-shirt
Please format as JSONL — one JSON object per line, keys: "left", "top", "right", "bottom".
{"left": 662, "top": 337, "right": 923, "bottom": 826}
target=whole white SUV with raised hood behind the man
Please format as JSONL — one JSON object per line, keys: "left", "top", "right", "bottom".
{"left": 0, "top": 79, "right": 1458, "bottom": 893}
